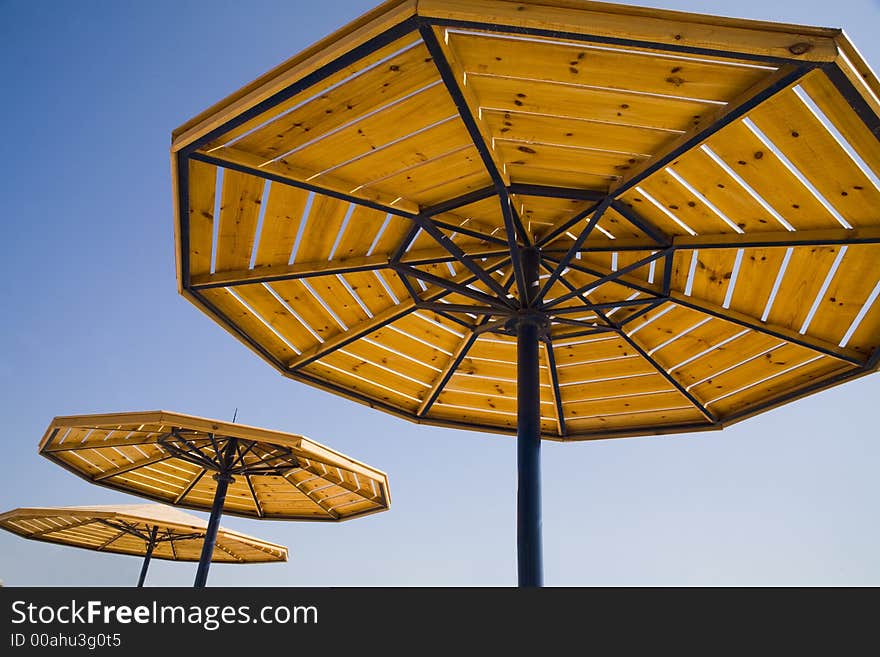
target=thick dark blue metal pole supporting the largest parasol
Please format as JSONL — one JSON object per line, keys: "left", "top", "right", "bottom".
{"left": 516, "top": 249, "right": 544, "bottom": 587}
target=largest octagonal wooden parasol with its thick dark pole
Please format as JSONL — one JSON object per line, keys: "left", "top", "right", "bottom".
{"left": 172, "top": 0, "right": 880, "bottom": 584}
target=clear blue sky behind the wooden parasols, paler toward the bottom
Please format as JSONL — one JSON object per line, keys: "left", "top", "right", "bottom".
{"left": 0, "top": 0, "right": 880, "bottom": 586}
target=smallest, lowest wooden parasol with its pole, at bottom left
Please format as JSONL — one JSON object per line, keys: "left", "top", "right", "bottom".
{"left": 0, "top": 504, "right": 287, "bottom": 586}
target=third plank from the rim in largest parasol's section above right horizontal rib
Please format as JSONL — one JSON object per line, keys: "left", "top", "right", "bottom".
{"left": 706, "top": 121, "right": 840, "bottom": 230}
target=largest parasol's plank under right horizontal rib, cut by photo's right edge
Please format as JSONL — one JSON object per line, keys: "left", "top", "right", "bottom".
{"left": 807, "top": 244, "right": 880, "bottom": 347}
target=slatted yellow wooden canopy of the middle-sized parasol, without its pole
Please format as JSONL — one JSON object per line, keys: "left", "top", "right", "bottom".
{"left": 41, "top": 414, "right": 390, "bottom": 520}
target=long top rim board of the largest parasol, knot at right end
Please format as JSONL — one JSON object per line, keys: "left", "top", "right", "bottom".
{"left": 418, "top": 0, "right": 838, "bottom": 61}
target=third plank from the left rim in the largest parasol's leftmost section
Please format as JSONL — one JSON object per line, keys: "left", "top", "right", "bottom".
{"left": 254, "top": 182, "right": 309, "bottom": 267}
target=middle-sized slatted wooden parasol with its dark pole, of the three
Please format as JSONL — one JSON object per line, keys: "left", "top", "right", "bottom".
{"left": 40, "top": 411, "right": 391, "bottom": 587}
